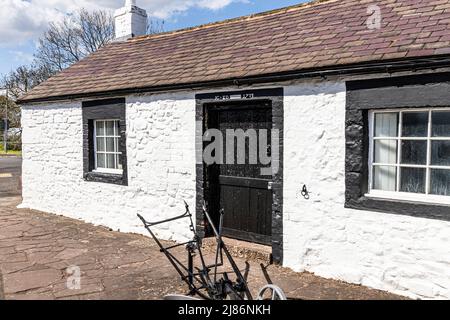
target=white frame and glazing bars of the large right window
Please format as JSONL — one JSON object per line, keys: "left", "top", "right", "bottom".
{"left": 365, "top": 108, "right": 450, "bottom": 204}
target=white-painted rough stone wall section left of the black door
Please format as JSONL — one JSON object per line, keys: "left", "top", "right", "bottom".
{"left": 21, "top": 94, "right": 195, "bottom": 241}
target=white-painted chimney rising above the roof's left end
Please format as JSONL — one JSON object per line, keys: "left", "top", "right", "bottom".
{"left": 114, "top": 0, "right": 147, "bottom": 40}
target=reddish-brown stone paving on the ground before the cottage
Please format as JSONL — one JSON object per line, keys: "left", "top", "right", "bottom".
{"left": 0, "top": 198, "right": 401, "bottom": 300}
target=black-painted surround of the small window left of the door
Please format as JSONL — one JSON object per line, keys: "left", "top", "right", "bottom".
{"left": 82, "top": 99, "right": 128, "bottom": 186}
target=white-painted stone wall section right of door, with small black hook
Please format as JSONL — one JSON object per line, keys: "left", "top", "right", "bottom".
{"left": 284, "top": 83, "right": 450, "bottom": 299}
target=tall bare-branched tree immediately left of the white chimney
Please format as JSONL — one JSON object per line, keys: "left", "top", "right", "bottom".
{"left": 35, "top": 9, "right": 114, "bottom": 72}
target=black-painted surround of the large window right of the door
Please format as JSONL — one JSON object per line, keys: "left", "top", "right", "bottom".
{"left": 345, "top": 73, "right": 450, "bottom": 221}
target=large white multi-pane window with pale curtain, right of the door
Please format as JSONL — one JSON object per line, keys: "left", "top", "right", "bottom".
{"left": 367, "top": 109, "right": 450, "bottom": 203}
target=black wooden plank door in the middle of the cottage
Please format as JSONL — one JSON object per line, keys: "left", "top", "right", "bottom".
{"left": 207, "top": 102, "right": 273, "bottom": 244}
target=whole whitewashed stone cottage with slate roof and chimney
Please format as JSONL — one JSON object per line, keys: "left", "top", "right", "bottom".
{"left": 16, "top": 0, "right": 450, "bottom": 299}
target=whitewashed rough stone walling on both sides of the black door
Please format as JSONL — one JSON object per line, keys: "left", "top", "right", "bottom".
{"left": 21, "top": 82, "right": 450, "bottom": 299}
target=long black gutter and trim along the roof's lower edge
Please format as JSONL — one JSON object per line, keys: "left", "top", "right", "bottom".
{"left": 17, "top": 54, "right": 450, "bottom": 105}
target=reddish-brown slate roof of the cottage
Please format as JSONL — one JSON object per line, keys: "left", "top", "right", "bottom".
{"left": 22, "top": 0, "right": 450, "bottom": 102}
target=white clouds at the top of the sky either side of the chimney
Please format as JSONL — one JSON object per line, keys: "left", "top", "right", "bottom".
{"left": 0, "top": 0, "right": 246, "bottom": 47}
